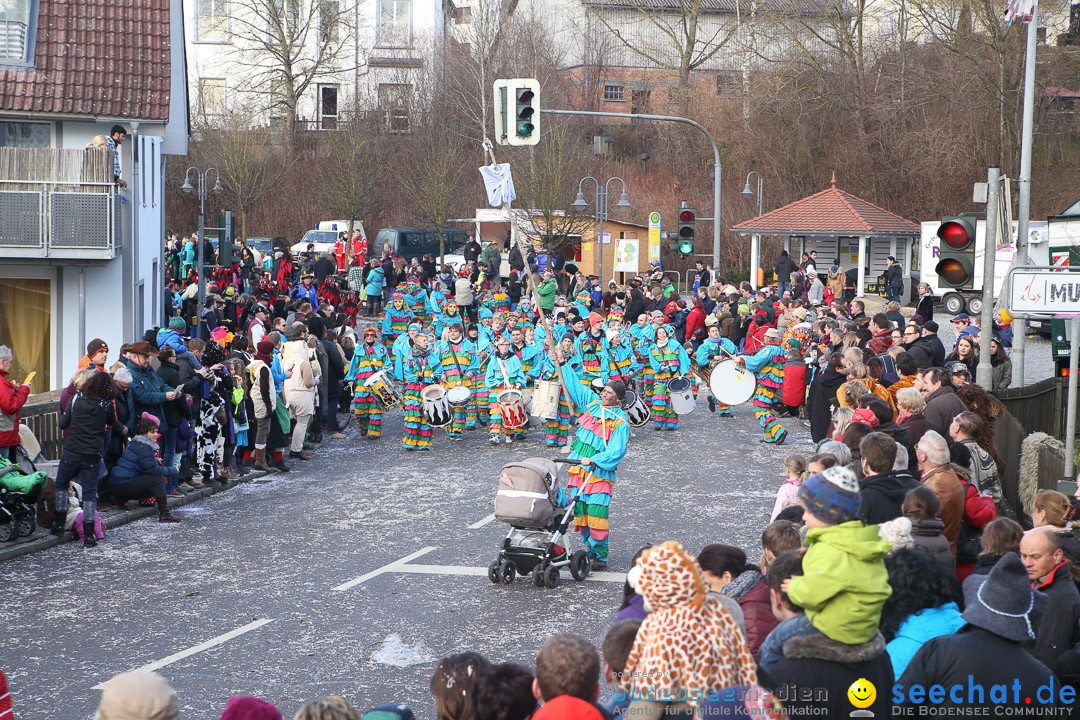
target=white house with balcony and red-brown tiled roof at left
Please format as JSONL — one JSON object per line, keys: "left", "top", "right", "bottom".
{"left": 0, "top": 0, "right": 188, "bottom": 393}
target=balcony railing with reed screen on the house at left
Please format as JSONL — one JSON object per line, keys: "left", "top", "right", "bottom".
{"left": 0, "top": 148, "right": 123, "bottom": 260}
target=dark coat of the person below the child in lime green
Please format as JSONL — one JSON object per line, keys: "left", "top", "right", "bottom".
{"left": 761, "top": 630, "right": 894, "bottom": 719}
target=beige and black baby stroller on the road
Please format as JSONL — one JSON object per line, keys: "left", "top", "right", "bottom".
{"left": 487, "top": 458, "right": 590, "bottom": 587}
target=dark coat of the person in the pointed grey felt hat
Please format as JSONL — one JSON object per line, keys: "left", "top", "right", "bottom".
{"left": 898, "top": 626, "right": 1058, "bottom": 717}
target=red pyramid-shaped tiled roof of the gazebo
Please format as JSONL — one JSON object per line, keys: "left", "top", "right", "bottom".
{"left": 732, "top": 180, "right": 919, "bottom": 235}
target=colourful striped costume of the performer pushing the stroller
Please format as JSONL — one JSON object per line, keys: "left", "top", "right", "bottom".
{"left": 563, "top": 363, "right": 630, "bottom": 562}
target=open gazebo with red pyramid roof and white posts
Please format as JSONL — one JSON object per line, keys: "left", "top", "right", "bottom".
{"left": 731, "top": 173, "right": 920, "bottom": 297}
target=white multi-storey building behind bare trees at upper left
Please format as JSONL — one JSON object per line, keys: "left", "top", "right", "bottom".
{"left": 184, "top": 0, "right": 445, "bottom": 127}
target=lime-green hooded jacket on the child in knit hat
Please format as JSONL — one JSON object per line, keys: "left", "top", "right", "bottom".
{"left": 787, "top": 520, "right": 892, "bottom": 644}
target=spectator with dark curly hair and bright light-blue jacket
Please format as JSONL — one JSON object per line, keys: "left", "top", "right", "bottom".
{"left": 881, "top": 548, "right": 964, "bottom": 678}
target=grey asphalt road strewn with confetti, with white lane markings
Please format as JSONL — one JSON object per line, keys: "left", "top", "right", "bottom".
{"left": 0, "top": 328, "right": 1051, "bottom": 720}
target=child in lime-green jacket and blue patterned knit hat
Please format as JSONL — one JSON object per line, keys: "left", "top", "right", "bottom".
{"left": 783, "top": 466, "right": 892, "bottom": 644}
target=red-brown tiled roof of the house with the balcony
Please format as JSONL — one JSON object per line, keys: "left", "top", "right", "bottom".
{"left": 0, "top": 0, "right": 171, "bottom": 120}
